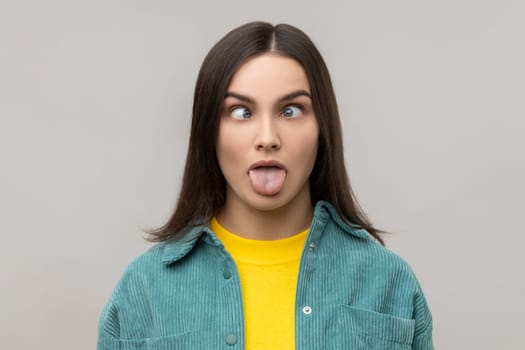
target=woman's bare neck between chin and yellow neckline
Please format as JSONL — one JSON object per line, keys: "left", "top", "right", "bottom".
{"left": 217, "top": 191, "right": 314, "bottom": 240}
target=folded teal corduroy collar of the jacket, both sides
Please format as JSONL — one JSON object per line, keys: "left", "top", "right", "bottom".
{"left": 161, "top": 201, "right": 372, "bottom": 265}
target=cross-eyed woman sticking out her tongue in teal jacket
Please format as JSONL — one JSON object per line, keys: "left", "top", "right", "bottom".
{"left": 98, "top": 22, "right": 433, "bottom": 350}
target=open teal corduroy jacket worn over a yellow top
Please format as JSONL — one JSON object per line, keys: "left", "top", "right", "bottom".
{"left": 97, "top": 201, "right": 433, "bottom": 350}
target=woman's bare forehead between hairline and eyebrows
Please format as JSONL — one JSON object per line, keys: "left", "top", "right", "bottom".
{"left": 228, "top": 53, "right": 310, "bottom": 99}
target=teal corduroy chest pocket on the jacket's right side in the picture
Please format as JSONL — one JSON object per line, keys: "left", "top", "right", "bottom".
{"left": 337, "top": 305, "right": 415, "bottom": 350}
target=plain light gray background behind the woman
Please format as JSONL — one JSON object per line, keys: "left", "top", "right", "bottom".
{"left": 0, "top": 0, "right": 525, "bottom": 350}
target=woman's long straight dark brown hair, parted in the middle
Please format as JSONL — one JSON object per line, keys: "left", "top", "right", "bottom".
{"left": 148, "top": 22, "right": 383, "bottom": 243}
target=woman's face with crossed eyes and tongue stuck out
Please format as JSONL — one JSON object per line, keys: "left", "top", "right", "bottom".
{"left": 216, "top": 54, "right": 319, "bottom": 211}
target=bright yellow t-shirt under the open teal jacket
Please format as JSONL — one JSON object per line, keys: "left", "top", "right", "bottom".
{"left": 210, "top": 217, "right": 308, "bottom": 350}
